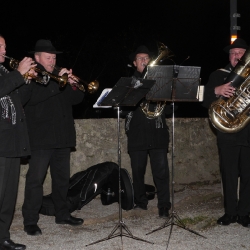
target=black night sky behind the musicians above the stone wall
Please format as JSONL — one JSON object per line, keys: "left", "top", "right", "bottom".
{"left": 0, "top": 0, "right": 250, "bottom": 119}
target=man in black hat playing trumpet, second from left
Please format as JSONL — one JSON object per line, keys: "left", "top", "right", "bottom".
{"left": 22, "top": 39, "right": 84, "bottom": 235}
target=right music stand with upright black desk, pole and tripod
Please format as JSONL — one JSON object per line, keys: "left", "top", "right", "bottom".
{"left": 146, "top": 65, "right": 206, "bottom": 248}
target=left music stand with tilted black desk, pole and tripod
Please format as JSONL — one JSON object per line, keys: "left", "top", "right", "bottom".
{"left": 86, "top": 77, "right": 155, "bottom": 246}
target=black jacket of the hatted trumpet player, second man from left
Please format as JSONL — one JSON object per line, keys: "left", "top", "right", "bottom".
{"left": 24, "top": 64, "right": 84, "bottom": 150}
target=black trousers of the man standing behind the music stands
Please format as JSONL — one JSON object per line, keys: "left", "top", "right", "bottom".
{"left": 129, "top": 149, "right": 171, "bottom": 209}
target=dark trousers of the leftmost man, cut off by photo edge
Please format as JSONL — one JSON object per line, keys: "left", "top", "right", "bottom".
{"left": 0, "top": 157, "right": 20, "bottom": 243}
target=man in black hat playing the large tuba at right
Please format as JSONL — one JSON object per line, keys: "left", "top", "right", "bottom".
{"left": 203, "top": 38, "right": 250, "bottom": 227}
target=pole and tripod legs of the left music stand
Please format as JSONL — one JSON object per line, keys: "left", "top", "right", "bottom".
{"left": 85, "top": 107, "right": 154, "bottom": 247}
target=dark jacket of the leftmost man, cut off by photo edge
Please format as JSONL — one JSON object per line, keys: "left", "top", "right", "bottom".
{"left": 0, "top": 66, "right": 30, "bottom": 157}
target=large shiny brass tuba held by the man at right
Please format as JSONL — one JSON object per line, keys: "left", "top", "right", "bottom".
{"left": 208, "top": 47, "right": 250, "bottom": 133}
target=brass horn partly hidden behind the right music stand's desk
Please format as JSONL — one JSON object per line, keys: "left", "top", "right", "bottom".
{"left": 140, "top": 43, "right": 174, "bottom": 119}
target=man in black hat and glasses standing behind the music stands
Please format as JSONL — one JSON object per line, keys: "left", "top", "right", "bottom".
{"left": 126, "top": 46, "right": 171, "bottom": 218}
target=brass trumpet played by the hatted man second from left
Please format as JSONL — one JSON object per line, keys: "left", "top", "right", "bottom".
{"left": 51, "top": 65, "right": 99, "bottom": 94}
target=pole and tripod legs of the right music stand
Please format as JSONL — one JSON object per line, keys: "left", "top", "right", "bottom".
{"left": 146, "top": 102, "right": 206, "bottom": 249}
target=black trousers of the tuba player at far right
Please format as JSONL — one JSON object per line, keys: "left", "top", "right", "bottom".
{"left": 219, "top": 146, "right": 250, "bottom": 216}
